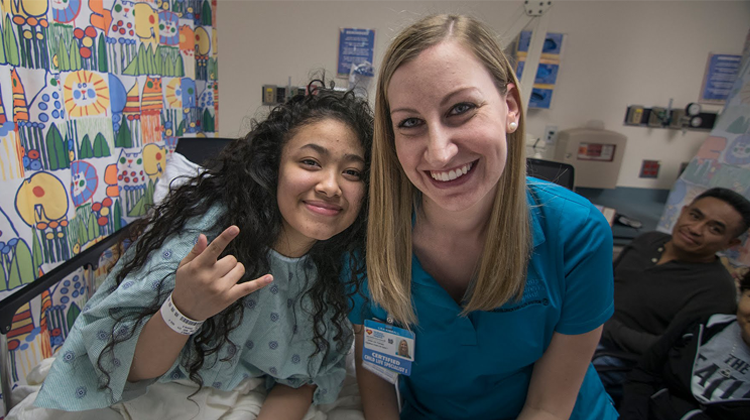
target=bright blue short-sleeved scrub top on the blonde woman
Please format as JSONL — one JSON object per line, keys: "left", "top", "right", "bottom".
{"left": 349, "top": 178, "right": 617, "bottom": 420}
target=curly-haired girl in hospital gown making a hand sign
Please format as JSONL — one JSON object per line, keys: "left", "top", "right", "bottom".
{"left": 35, "top": 85, "right": 372, "bottom": 419}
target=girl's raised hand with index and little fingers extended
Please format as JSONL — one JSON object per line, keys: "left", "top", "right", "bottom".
{"left": 172, "top": 225, "right": 273, "bottom": 321}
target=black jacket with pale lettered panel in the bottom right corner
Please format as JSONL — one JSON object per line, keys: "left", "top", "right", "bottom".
{"left": 619, "top": 315, "right": 750, "bottom": 420}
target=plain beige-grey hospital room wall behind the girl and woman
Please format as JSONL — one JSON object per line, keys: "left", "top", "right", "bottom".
{"left": 217, "top": 0, "right": 750, "bottom": 188}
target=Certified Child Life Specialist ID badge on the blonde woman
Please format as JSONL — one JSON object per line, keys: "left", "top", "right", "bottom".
{"left": 362, "top": 320, "right": 415, "bottom": 376}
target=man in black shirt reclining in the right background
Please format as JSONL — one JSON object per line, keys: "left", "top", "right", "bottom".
{"left": 594, "top": 188, "right": 750, "bottom": 398}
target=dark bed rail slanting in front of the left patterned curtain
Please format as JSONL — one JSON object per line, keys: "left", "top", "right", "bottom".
{"left": 0, "top": 225, "right": 130, "bottom": 335}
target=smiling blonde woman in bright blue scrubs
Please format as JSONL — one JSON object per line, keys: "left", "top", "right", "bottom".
{"left": 350, "top": 15, "right": 617, "bottom": 420}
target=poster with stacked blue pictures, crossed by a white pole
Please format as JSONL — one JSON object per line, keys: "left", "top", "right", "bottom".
{"left": 516, "top": 31, "right": 565, "bottom": 109}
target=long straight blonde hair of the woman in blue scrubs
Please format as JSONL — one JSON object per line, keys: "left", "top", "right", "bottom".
{"left": 367, "top": 15, "right": 531, "bottom": 326}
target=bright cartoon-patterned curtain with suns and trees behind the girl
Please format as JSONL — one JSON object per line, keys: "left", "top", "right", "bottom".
{"left": 0, "top": 0, "right": 218, "bottom": 419}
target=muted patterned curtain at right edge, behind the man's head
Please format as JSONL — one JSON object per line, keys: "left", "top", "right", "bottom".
{"left": 657, "top": 33, "right": 750, "bottom": 276}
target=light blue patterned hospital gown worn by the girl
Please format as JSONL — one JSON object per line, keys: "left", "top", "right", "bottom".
{"left": 34, "top": 206, "right": 351, "bottom": 411}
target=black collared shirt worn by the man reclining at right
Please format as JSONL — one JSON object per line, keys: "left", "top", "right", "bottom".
{"left": 602, "top": 232, "right": 737, "bottom": 354}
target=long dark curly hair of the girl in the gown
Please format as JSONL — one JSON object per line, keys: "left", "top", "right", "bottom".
{"left": 97, "top": 80, "right": 373, "bottom": 398}
